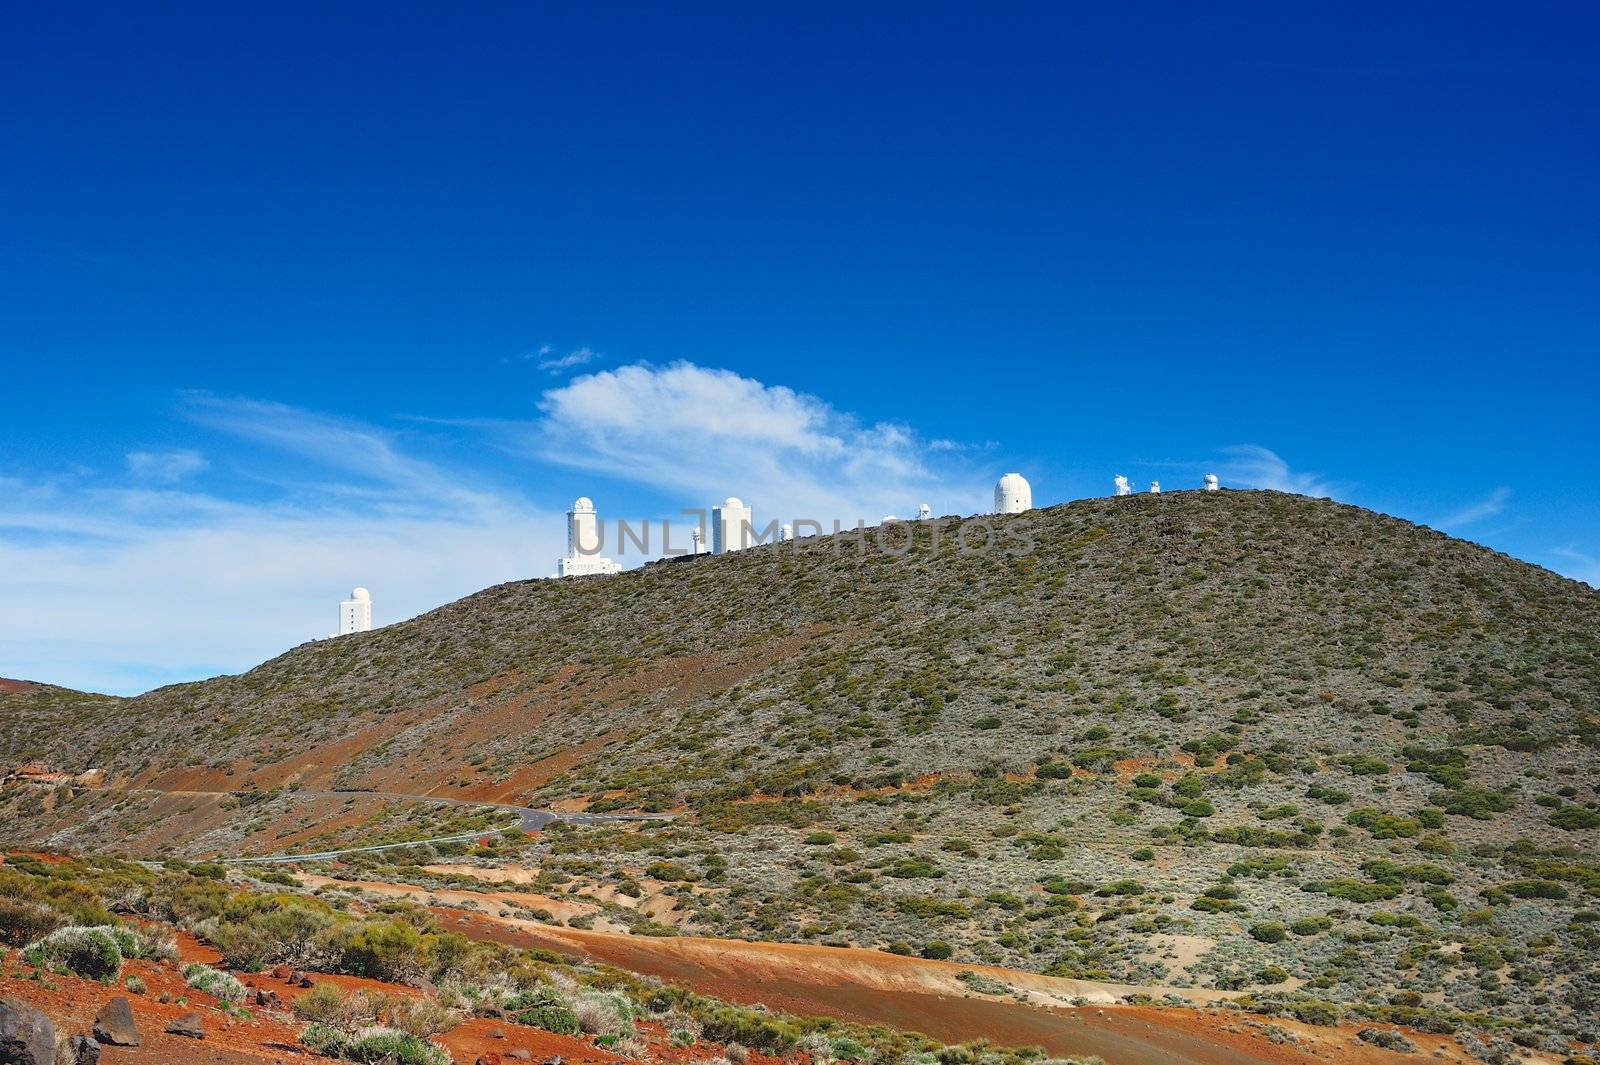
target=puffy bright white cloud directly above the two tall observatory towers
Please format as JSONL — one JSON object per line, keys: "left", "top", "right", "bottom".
{"left": 534, "top": 361, "right": 984, "bottom": 526}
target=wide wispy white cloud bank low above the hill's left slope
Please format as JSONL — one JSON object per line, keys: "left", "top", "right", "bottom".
{"left": 0, "top": 397, "right": 563, "bottom": 694}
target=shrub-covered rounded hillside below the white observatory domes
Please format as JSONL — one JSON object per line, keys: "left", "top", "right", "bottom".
{"left": 0, "top": 493, "right": 1600, "bottom": 1041}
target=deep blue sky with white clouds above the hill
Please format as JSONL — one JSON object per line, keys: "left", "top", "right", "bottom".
{"left": 0, "top": 3, "right": 1600, "bottom": 692}
